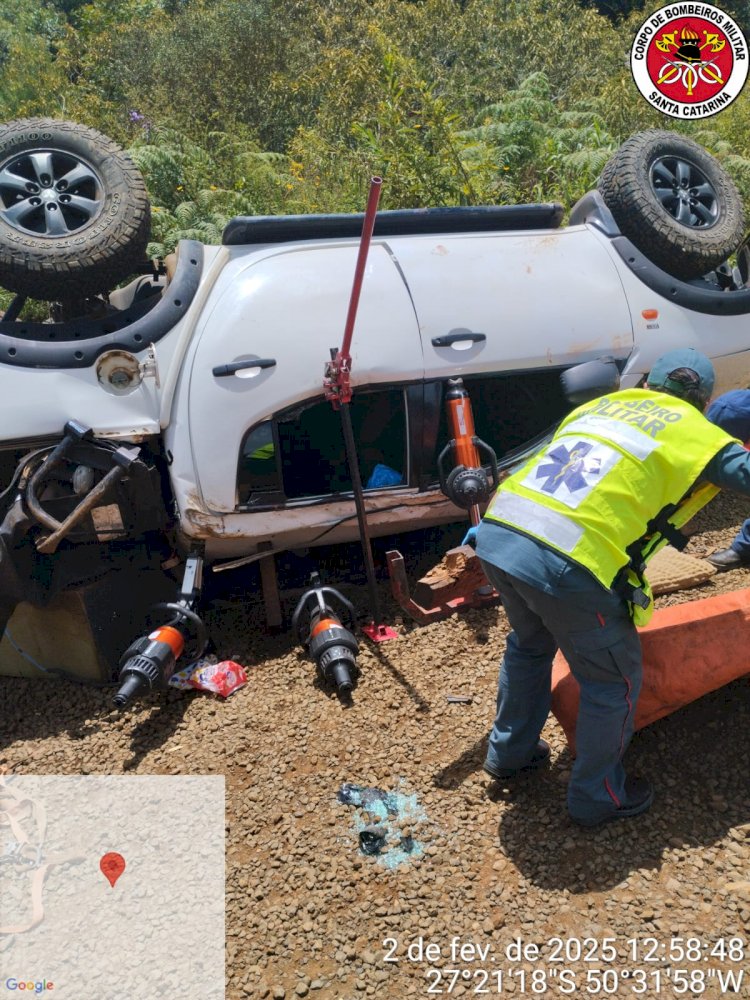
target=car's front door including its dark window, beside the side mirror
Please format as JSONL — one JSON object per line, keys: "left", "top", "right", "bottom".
{"left": 393, "top": 226, "right": 633, "bottom": 483}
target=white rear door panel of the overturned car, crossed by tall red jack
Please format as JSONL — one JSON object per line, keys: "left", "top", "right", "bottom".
{"left": 186, "top": 241, "right": 424, "bottom": 512}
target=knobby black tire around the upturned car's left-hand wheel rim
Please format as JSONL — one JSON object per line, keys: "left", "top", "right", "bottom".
{"left": 0, "top": 118, "right": 150, "bottom": 301}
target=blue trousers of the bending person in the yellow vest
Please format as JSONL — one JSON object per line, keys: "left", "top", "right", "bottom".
{"left": 482, "top": 561, "right": 642, "bottom": 821}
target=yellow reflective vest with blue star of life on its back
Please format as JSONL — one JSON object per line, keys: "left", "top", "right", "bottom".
{"left": 485, "top": 388, "right": 735, "bottom": 624}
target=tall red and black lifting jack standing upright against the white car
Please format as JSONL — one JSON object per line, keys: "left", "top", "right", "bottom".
{"left": 323, "top": 177, "right": 398, "bottom": 642}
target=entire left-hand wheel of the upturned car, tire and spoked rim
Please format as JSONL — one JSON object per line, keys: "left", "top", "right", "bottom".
{"left": 0, "top": 118, "right": 150, "bottom": 301}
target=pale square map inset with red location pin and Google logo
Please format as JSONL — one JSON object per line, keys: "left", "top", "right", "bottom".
{"left": 0, "top": 775, "right": 225, "bottom": 1000}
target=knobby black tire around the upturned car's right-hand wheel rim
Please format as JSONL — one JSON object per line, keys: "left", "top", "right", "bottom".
{"left": 598, "top": 129, "right": 745, "bottom": 280}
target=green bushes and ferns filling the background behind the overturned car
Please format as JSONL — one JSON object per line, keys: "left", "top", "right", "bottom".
{"left": 0, "top": 0, "right": 750, "bottom": 255}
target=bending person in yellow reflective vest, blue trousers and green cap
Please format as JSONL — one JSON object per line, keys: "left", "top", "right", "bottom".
{"left": 476, "top": 349, "right": 750, "bottom": 826}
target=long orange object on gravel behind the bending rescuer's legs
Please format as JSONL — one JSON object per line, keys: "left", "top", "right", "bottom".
{"left": 552, "top": 588, "right": 750, "bottom": 753}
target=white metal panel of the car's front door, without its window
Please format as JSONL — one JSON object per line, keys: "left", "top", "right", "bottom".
{"left": 394, "top": 226, "right": 633, "bottom": 379}
